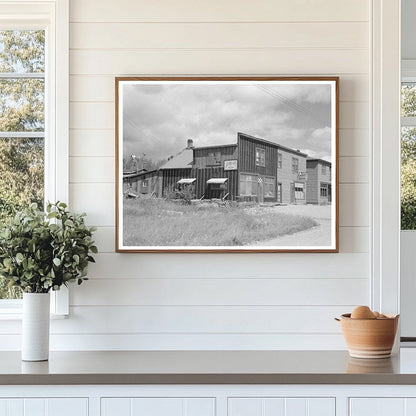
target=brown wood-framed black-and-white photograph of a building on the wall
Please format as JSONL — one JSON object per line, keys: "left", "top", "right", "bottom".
{"left": 116, "top": 77, "right": 339, "bottom": 253}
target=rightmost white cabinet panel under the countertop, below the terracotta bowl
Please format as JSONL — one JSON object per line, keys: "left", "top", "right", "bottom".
{"left": 350, "top": 398, "right": 416, "bottom": 416}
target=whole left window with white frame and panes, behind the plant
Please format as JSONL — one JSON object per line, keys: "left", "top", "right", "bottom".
{"left": 0, "top": 0, "right": 68, "bottom": 313}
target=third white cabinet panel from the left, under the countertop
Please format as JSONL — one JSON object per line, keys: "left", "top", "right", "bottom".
{"left": 228, "top": 397, "right": 335, "bottom": 416}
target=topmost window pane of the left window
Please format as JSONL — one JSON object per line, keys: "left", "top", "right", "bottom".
{"left": 0, "top": 30, "right": 45, "bottom": 72}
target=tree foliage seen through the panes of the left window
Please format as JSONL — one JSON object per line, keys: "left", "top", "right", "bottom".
{"left": 0, "top": 30, "right": 45, "bottom": 299}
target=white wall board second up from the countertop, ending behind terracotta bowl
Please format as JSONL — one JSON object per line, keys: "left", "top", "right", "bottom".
{"left": 51, "top": 306, "right": 354, "bottom": 335}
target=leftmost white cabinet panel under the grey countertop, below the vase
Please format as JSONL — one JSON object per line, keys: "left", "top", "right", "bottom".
{"left": 0, "top": 398, "right": 88, "bottom": 416}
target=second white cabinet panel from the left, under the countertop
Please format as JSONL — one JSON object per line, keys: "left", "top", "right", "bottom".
{"left": 101, "top": 397, "right": 215, "bottom": 416}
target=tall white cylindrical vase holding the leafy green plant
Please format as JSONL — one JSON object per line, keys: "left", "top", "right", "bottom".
{"left": 22, "top": 293, "right": 50, "bottom": 361}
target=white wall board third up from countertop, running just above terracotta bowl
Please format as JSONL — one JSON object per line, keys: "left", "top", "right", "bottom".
{"left": 70, "top": 276, "right": 368, "bottom": 306}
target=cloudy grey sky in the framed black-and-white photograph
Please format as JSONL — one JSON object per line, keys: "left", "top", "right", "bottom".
{"left": 123, "top": 81, "right": 331, "bottom": 162}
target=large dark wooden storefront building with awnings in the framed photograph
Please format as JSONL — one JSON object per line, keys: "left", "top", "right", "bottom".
{"left": 125, "top": 133, "right": 320, "bottom": 204}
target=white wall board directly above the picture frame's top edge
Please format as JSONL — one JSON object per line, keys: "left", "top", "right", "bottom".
{"left": 70, "top": 48, "right": 368, "bottom": 76}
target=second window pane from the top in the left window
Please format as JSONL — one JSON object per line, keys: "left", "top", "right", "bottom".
{"left": 0, "top": 78, "right": 45, "bottom": 132}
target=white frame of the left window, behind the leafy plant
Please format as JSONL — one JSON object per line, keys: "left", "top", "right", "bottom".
{"left": 0, "top": 0, "right": 69, "bottom": 319}
